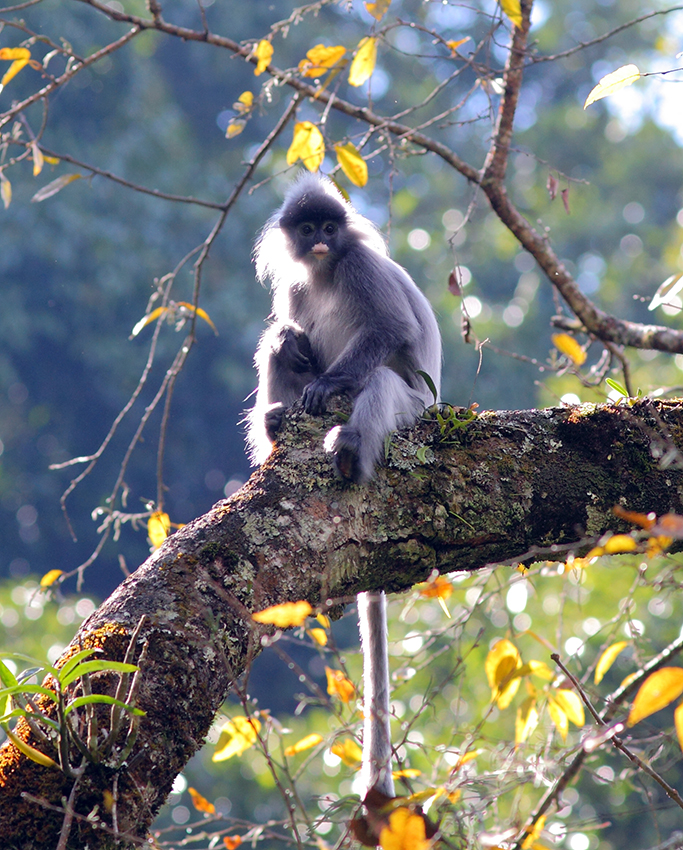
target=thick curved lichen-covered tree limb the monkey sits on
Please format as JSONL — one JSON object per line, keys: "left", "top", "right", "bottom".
{"left": 0, "top": 401, "right": 683, "bottom": 850}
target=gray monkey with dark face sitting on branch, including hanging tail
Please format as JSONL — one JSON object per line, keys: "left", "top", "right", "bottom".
{"left": 247, "top": 174, "right": 441, "bottom": 796}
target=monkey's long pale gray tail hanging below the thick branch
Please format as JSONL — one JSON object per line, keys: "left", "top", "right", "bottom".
{"left": 358, "top": 591, "right": 394, "bottom": 797}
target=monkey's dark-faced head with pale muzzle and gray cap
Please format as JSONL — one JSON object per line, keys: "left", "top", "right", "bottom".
{"left": 279, "top": 180, "right": 348, "bottom": 268}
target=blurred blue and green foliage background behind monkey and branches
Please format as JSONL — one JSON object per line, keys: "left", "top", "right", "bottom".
{"left": 0, "top": 0, "right": 683, "bottom": 850}
